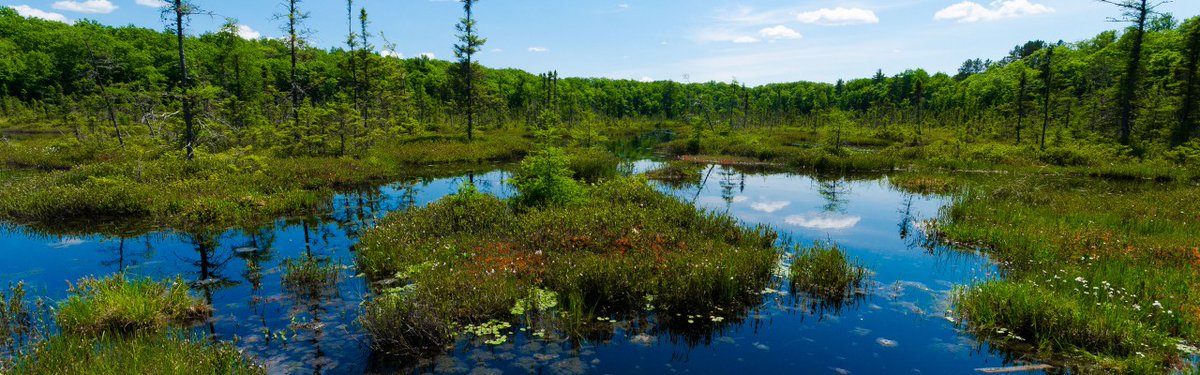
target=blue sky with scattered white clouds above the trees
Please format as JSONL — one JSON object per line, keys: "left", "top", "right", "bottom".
{"left": 0, "top": 0, "right": 1200, "bottom": 84}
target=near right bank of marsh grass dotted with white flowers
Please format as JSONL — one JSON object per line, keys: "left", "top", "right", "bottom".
{"left": 937, "top": 177, "right": 1200, "bottom": 373}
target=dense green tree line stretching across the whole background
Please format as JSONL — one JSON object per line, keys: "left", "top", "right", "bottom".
{"left": 0, "top": 0, "right": 1200, "bottom": 155}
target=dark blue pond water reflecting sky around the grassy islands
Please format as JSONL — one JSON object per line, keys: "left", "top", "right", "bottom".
{"left": 0, "top": 162, "right": 1027, "bottom": 374}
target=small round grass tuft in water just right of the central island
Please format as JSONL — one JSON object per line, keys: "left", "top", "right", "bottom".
{"left": 788, "top": 242, "right": 868, "bottom": 309}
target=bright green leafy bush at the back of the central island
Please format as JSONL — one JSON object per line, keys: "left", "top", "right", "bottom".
{"left": 512, "top": 148, "right": 583, "bottom": 207}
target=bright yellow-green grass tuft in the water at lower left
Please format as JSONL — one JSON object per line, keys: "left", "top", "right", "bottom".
{"left": 56, "top": 274, "right": 211, "bottom": 334}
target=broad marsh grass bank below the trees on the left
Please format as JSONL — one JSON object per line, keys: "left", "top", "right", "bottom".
{"left": 0, "top": 132, "right": 529, "bottom": 230}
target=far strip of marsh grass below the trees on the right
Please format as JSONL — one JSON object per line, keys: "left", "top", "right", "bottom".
{"left": 659, "top": 126, "right": 1200, "bottom": 181}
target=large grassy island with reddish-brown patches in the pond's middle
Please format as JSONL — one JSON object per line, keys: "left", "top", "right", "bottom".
{"left": 358, "top": 178, "right": 778, "bottom": 351}
